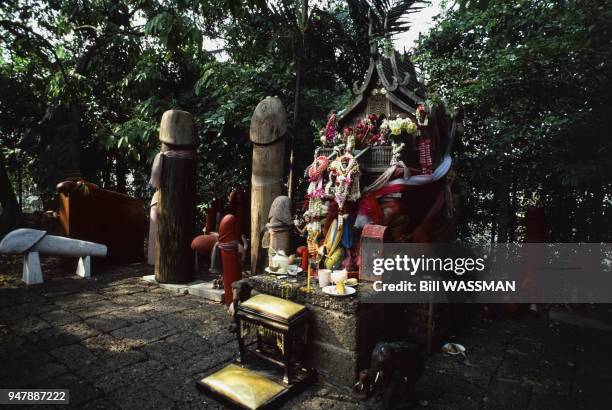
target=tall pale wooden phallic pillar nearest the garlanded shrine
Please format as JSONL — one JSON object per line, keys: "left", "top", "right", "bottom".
{"left": 250, "top": 97, "right": 287, "bottom": 273}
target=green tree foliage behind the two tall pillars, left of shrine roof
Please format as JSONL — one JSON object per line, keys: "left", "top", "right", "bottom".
{"left": 0, "top": 0, "right": 367, "bottom": 215}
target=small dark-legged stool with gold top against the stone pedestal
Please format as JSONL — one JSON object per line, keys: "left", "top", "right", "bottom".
{"left": 235, "top": 294, "right": 310, "bottom": 384}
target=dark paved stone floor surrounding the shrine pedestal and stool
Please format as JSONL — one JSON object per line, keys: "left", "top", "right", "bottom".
{"left": 0, "top": 257, "right": 612, "bottom": 409}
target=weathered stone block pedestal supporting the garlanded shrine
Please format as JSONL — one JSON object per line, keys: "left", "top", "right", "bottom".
{"left": 248, "top": 274, "right": 465, "bottom": 390}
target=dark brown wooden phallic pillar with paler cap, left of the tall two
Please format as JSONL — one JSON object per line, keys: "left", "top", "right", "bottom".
{"left": 151, "top": 110, "right": 197, "bottom": 283}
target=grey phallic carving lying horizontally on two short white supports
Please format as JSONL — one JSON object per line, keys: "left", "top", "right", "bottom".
{"left": 0, "top": 228, "right": 107, "bottom": 285}
